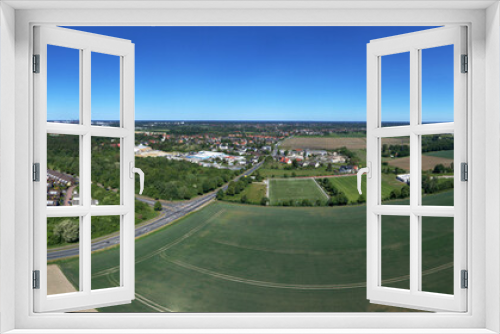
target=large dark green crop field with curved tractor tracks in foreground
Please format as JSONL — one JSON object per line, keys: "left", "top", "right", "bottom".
{"left": 52, "top": 193, "right": 453, "bottom": 312}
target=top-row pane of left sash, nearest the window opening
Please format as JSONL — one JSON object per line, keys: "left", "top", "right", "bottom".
{"left": 91, "top": 52, "right": 120, "bottom": 126}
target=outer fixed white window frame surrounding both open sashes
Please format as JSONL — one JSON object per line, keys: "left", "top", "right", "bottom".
{"left": 0, "top": 0, "right": 500, "bottom": 333}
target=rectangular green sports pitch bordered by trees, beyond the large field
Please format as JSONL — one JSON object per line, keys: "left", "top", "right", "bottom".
{"left": 269, "top": 179, "right": 328, "bottom": 205}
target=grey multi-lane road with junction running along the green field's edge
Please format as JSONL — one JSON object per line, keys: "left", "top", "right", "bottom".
{"left": 47, "top": 161, "right": 264, "bottom": 261}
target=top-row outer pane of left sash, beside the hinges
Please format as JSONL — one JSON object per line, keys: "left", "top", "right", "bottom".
{"left": 47, "top": 45, "right": 80, "bottom": 124}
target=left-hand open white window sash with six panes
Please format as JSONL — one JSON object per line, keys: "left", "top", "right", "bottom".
{"left": 33, "top": 26, "right": 135, "bottom": 312}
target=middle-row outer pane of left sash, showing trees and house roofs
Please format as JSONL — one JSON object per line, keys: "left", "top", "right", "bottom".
{"left": 47, "top": 133, "right": 80, "bottom": 206}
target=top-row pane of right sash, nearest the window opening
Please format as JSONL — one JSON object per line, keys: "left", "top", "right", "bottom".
{"left": 380, "top": 52, "right": 410, "bottom": 127}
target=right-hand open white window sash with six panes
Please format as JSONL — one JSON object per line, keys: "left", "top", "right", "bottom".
{"left": 366, "top": 25, "right": 473, "bottom": 312}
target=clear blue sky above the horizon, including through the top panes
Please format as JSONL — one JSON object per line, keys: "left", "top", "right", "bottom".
{"left": 48, "top": 27, "right": 453, "bottom": 121}
